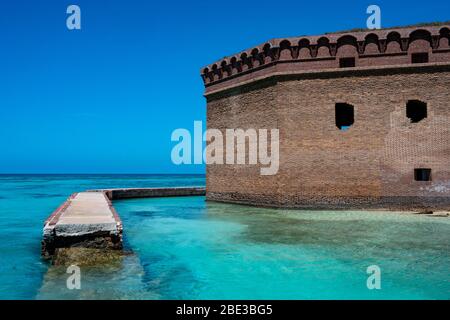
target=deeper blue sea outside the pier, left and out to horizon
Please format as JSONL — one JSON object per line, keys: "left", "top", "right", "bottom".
{"left": 0, "top": 175, "right": 205, "bottom": 299}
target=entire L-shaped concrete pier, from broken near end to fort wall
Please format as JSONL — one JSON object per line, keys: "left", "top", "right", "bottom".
{"left": 42, "top": 187, "right": 206, "bottom": 258}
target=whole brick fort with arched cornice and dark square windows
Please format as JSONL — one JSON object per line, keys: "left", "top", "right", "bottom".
{"left": 201, "top": 25, "right": 450, "bottom": 210}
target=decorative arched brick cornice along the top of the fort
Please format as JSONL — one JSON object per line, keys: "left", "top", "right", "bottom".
{"left": 201, "top": 25, "right": 450, "bottom": 91}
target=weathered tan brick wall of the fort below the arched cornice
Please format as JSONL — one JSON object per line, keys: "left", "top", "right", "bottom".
{"left": 206, "top": 25, "right": 450, "bottom": 209}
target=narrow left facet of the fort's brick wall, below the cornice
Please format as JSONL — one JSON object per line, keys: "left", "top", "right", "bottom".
{"left": 206, "top": 81, "right": 279, "bottom": 204}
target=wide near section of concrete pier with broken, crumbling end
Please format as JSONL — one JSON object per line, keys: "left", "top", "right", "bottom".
{"left": 42, "top": 192, "right": 122, "bottom": 257}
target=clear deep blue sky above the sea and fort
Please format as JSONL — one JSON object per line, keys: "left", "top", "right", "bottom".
{"left": 0, "top": 0, "right": 450, "bottom": 173}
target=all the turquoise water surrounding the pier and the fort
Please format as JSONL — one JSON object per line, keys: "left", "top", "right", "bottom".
{"left": 0, "top": 176, "right": 450, "bottom": 299}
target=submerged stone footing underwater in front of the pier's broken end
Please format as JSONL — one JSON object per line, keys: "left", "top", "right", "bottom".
{"left": 36, "top": 248, "right": 155, "bottom": 300}
